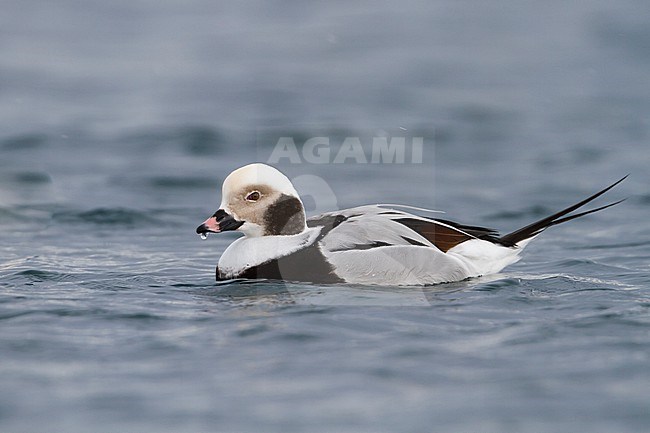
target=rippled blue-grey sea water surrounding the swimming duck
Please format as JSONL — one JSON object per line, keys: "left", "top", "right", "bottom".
{"left": 0, "top": 0, "right": 650, "bottom": 433}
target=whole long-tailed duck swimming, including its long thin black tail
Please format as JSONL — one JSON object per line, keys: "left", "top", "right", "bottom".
{"left": 196, "top": 164, "right": 627, "bottom": 285}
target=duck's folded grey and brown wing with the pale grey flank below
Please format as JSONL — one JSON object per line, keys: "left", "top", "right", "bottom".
{"left": 307, "top": 206, "right": 477, "bottom": 285}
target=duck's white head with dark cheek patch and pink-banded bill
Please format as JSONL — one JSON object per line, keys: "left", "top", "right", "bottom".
{"left": 196, "top": 163, "right": 307, "bottom": 237}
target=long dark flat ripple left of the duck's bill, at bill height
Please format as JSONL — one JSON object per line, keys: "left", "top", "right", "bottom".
{"left": 52, "top": 208, "right": 156, "bottom": 227}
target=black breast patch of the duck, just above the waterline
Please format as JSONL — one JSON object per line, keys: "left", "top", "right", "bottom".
{"left": 217, "top": 243, "right": 343, "bottom": 284}
